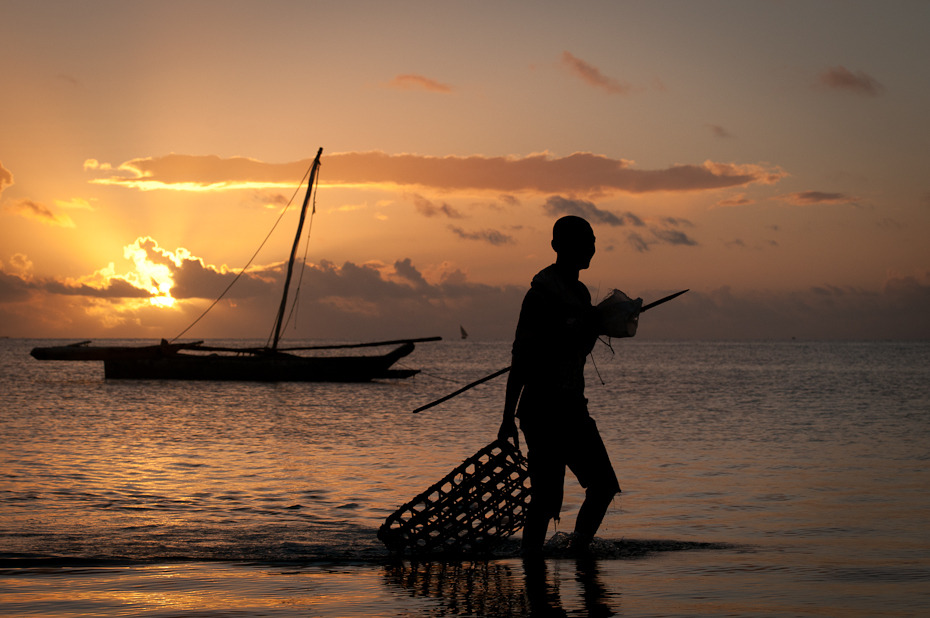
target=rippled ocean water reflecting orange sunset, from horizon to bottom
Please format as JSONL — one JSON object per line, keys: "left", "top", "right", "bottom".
{"left": 0, "top": 339, "right": 930, "bottom": 617}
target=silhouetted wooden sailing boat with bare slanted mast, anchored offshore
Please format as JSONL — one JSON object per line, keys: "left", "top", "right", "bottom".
{"left": 31, "top": 148, "right": 441, "bottom": 382}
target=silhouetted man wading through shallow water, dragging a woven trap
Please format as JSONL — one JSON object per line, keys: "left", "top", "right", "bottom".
{"left": 498, "top": 216, "right": 620, "bottom": 556}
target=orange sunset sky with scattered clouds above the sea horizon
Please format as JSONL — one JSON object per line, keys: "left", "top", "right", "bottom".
{"left": 0, "top": 0, "right": 930, "bottom": 340}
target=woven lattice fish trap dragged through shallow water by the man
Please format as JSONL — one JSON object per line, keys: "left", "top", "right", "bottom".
{"left": 378, "top": 440, "right": 530, "bottom": 554}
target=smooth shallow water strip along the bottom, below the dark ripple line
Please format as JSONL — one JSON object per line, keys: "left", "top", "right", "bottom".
{"left": 9, "top": 550, "right": 930, "bottom": 618}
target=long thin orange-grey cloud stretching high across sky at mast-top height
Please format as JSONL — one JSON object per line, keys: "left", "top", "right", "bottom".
{"left": 87, "top": 152, "right": 786, "bottom": 195}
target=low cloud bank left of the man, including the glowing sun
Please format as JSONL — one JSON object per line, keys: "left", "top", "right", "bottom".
{"left": 0, "top": 233, "right": 524, "bottom": 340}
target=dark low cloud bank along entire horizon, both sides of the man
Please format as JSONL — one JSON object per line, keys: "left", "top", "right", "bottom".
{"left": 0, "top": 253, "right": 930, "bottom": 340}
